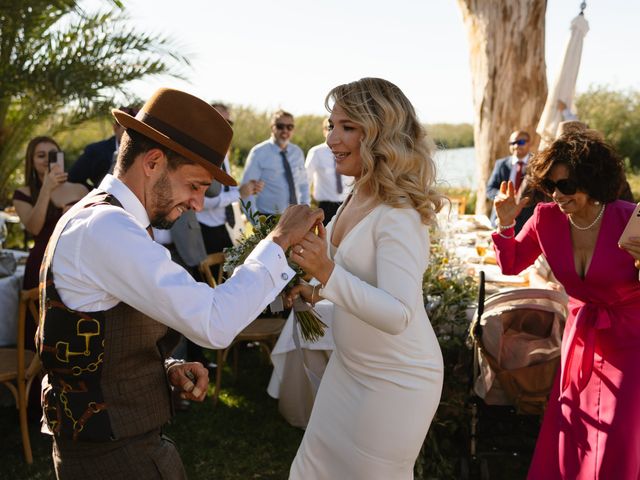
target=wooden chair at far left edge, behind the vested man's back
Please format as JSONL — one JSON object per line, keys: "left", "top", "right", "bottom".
{"left": 0, "top": 288, "right": 41, "bottom": 463}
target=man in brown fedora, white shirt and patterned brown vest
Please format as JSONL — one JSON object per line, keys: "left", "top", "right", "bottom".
{"left": 36, "top": 89, "right": 323, "bottom": 480}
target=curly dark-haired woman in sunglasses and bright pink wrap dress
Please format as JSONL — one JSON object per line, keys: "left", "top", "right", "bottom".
{"left": 493, "top": 131, "right": 640, "bottom": 480}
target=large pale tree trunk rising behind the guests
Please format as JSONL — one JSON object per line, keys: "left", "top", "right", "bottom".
{"left": 458, "top": 0, "right": 547, "bottom": 214}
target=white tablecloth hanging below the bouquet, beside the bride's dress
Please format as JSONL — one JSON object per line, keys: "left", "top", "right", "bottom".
{"left": 267, "top": 300, "right": 335, "bottom": 427}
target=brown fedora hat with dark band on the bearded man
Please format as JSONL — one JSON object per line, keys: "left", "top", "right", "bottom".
{"left": 111, "top": 88, "right": 237, "bottom": 185}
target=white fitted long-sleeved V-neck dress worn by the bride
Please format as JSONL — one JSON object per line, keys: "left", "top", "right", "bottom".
{"left": 289, "top": 205, "right": 443, "bottom": 480}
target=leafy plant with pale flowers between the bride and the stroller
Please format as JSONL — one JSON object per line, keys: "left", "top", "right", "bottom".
{"left": 415, "top": 240, "right": 478, "bottom": 480}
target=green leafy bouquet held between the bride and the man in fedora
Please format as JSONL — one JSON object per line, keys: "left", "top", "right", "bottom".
{"left": 222, "top": 200, "right": 327, "bottom": 342}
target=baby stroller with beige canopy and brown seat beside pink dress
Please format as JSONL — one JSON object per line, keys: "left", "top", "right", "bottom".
{"left": 462, "top": 272, "right": 568, "bottom": 479}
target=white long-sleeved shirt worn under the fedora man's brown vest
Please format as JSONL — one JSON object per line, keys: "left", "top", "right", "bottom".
{"left": 51, "top": 175, "right": 294, "bottom": 348}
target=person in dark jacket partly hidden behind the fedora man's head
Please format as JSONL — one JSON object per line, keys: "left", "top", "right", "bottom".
{"left": 69, "top": 106, "right": 139, "bottom": 188}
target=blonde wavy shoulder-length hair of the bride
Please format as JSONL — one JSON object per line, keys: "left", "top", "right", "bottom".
{"left": 325, "top": 78, "right": 444, "bottom": 225}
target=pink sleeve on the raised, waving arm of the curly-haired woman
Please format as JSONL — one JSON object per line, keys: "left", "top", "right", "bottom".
{"left": 491, "top": 205, "right": 542, "bottom": 275}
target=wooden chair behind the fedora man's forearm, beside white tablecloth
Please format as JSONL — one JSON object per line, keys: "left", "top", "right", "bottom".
{"left": 200, "top": 253, "right": 285, "bottom": 405}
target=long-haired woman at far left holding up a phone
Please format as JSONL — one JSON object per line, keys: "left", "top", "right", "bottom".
{"left": 13, "top": 137, "right": 88, "bottom": 342}
